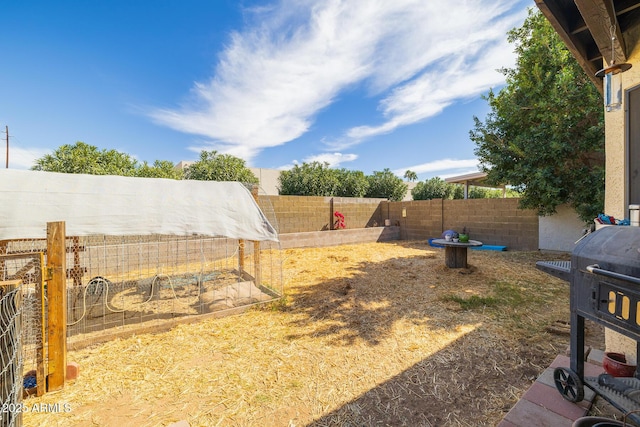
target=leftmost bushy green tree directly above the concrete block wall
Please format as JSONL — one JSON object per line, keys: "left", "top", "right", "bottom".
{"left": 278, "top": 162, "right": 340, "bottom": 196}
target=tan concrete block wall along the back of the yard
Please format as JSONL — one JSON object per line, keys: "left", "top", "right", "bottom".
{"left": 269, "top": 196, "right": 539, "bottom": 250}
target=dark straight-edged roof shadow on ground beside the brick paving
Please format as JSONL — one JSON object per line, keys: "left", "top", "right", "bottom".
{"left": 307, "top": 330, "right": 562, "bottom": 427}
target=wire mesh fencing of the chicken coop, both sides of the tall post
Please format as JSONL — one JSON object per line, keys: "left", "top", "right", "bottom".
{"left": 0, "top": 231, "right": 283, "bottom": 427}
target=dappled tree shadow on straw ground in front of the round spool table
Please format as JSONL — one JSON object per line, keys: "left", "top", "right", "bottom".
{"left": 289, "top": 243, "right": 524, "bottom": 345}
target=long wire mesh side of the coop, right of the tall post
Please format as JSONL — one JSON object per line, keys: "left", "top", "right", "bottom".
{"left": 67, "top": 235, "right": 282, "bottom": 344}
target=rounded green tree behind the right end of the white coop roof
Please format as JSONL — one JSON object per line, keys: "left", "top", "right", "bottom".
{"left": 184, "top": 150, "right": 259, "bottom": 184}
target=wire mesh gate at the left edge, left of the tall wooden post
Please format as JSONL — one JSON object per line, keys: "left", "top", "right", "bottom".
{"left": 0, "top": 252, "right": 45, "bottom": 427}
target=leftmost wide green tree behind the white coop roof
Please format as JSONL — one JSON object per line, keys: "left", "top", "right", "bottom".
{"left": 31, "top": 141, "right": 137, "bottom": 176}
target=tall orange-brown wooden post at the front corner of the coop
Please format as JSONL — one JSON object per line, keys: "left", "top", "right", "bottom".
{"left": 47, "top": 222, "right": 67, "bottom": 391}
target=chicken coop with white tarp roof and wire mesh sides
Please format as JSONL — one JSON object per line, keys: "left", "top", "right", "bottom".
{"left": 0, "top": 169, "right": 283, "bottom": 425}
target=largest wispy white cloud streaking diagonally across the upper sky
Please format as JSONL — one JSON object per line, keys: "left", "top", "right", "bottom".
{"left": 150, "top": 0, "right": 525, "bottom": 162}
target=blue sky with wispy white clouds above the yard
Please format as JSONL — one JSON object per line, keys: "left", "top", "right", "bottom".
{"left": 0, "top": 0, "right": 535, "bottom": 180}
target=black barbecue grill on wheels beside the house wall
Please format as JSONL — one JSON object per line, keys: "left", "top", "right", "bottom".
{"left": 536, "top": 226, "right": 640, "bottom": 423}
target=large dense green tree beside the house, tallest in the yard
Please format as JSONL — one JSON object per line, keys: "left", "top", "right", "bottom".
{"left": 470, "top": 11, "right": 604, "bottom": 221}
